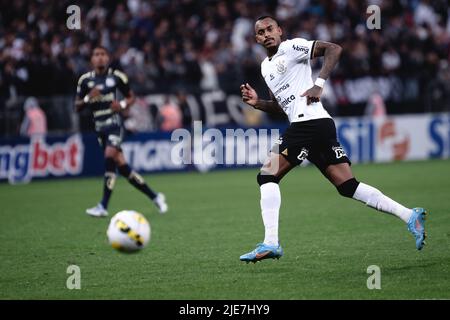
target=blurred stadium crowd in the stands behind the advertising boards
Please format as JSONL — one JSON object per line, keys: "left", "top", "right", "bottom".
{"left": 0, "top": 0, "right": 450, "bottom": 134}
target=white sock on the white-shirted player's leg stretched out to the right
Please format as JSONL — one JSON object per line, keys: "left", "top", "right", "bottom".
{"left": 353, "top": 182, "right": 412, "bottom": 223}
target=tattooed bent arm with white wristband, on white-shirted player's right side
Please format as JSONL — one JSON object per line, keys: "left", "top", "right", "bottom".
{"left": 302, "top": 40, "right": 342, "bottom": 104}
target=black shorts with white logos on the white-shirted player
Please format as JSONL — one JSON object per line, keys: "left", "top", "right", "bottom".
{"left": 272, "top": 118, "right": 351, "bottom": 172}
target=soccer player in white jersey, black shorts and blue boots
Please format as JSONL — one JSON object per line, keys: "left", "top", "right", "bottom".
{"left": 240, "top": 16, "right": 427, "bottom": 262}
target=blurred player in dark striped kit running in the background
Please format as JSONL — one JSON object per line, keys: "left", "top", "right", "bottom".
{"left": 75, "top": 46, "right": 168, "bottom": 217}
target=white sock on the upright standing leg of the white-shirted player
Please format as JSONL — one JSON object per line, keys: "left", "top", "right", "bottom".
{"left": 260, "top": 182, "right": 281, "bottom": 246}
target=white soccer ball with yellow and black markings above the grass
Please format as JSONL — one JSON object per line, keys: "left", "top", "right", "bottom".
{"left": 106, "top": 210, "right": 151, "bottom": 252}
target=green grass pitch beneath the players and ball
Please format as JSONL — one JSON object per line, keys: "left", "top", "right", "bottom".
{"left": 0, "top": 160, "right": 450, "bottom": 300}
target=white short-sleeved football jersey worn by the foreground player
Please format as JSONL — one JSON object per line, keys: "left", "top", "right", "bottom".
{"left": 261, "top": 38, "right": 331, "bottom": 123}
